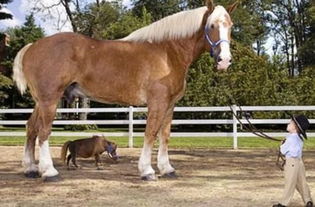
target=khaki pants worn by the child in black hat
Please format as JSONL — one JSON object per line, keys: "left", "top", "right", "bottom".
{"left": 280, "top": 158, "right": 312, "bottom": 206}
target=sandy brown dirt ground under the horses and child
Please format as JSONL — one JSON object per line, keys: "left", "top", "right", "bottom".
{"left": 0, "top": 146, "right": 315, "bottom": 207}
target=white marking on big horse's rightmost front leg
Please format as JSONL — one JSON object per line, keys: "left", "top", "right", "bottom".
{"left": 158, "top": 137, "right": 175, "bottom": 175}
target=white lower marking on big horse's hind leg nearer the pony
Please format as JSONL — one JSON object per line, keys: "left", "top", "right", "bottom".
{"left": 39, "top": 140, "right": 58, "bottom": 178}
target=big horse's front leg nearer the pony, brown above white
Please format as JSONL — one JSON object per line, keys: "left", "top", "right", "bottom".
{"left": 138, "top": 92, "right": 169, "bottom": 181}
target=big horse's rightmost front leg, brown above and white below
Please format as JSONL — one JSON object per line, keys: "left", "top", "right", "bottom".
{"left": 158, "top": 107, "right": 176, "bottom": 178}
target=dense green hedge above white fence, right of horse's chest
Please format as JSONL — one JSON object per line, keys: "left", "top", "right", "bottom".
{"left": 179, "top": 43, "right": 315, "bottom": 109}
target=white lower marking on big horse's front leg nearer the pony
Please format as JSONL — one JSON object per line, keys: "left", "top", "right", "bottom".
{"left": 138, "top": 143, "right": 155, "bottom": 177}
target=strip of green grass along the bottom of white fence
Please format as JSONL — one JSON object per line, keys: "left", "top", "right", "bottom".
{"left": 0, "top": 137, "right": 315, "bottom": 149}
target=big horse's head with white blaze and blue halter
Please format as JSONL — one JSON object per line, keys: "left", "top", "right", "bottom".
{"left": 205, "top": 0, "right": 238, "bottom": 70}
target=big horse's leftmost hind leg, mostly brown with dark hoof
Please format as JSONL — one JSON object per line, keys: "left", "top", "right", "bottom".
{"left": 23, "top": 106, "right": 40, "bottom": 178}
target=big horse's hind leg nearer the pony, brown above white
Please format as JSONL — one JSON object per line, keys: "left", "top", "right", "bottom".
{"left": 38, "top": 101, "right": 59, "bottom": 181}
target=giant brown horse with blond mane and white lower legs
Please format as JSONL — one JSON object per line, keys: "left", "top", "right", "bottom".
{"left": 13, "top": 0, "right": 237, "bottom": 181}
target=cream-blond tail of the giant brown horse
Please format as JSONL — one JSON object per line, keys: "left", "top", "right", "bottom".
{"left": 13, "top": 43, "right": 33, "bottom": 95}
